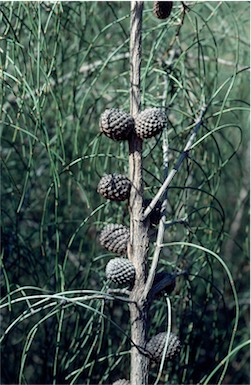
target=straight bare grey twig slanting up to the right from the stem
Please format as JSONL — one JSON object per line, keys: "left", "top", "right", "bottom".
{"left": 142, "top": 106, "right": 206, "bottom": 220}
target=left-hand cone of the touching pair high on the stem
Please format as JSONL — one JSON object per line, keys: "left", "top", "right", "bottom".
{"left": 99, "top": 108, "right": 134, "bottom": 140}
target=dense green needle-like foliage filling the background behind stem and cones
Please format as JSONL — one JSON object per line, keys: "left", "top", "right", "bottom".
{"left": 0, "top": 1, "right": 250, "bottom": 384}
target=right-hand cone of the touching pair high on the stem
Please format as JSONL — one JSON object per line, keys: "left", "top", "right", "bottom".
{"left": 135, "top": 108, "right": 167, "bottom": 139}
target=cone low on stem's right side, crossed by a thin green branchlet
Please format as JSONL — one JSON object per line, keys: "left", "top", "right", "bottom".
{"left": 146, "top": 332, "right": 180, "bottom": 361}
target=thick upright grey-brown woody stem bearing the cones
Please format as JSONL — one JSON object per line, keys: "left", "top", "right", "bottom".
{"left": 128, "top": 0, "right": 149, "bottom": 385}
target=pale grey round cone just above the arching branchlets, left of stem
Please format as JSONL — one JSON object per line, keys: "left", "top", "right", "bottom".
{"left": 106, "top": 258, "right": 135, "bottom": 285}
